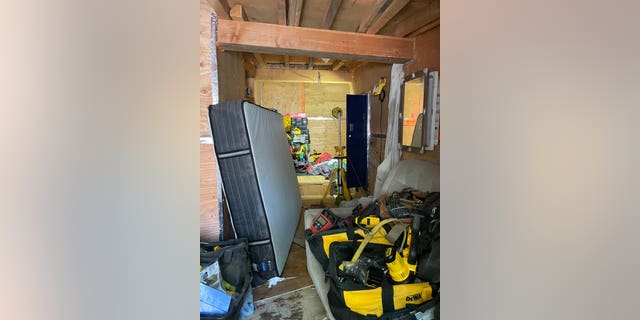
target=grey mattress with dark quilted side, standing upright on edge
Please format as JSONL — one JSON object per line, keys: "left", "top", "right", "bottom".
{"left": 209, "top": 101, "right": 302, "bottom": 285}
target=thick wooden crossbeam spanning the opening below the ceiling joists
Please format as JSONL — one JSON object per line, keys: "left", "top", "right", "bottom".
{"left": 217, "top": 20, "right": 413, "bottom": 63}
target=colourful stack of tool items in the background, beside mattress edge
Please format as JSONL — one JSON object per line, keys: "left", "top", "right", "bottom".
{"left": 282, "top": 113, "right": 311, "bottom": 172}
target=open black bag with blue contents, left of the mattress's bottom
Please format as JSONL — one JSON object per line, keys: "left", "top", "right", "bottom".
{"left": 200, "top": 238, "right": 252, "bottom": 320}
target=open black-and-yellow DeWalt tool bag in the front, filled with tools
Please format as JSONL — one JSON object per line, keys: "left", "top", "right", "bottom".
{"left": 326, "top": 219, "right": 433, "bottom": 319}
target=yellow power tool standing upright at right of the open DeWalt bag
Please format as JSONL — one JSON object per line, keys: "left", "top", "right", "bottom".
{"left": 385, "top": 215, "right": 421, "bottom": 283}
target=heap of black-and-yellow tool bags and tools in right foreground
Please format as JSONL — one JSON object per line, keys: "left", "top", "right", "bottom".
{"left": 305, "top": 188, "right": 440, "bottom": 320}
